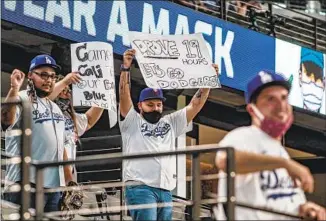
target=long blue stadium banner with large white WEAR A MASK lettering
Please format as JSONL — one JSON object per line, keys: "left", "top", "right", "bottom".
{"left": 1, "top": 0, "right": 325, "bottom": 113}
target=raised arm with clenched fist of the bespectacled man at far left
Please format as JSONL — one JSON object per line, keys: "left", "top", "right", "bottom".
{"left": 1, "top": 69, "right": 25, "bottom": 127}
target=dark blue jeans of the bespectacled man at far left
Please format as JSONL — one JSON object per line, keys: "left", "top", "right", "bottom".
{"left": 4, "top": 184, "right": 61, "bottom": 212}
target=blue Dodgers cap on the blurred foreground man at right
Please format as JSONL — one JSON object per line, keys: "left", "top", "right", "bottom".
{"left": 245, "top": 70, "right": 291, "bottom": 104}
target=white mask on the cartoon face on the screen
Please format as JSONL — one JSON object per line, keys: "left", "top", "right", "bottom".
{"left": 301, "top": 81, "right": 324, "bottom": 111}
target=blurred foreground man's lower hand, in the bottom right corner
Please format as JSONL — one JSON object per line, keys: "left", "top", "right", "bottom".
{"left": 299, "top": 202, "right": 326, "bottom": 220}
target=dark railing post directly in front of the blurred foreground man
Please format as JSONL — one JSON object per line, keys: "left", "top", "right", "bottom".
{"left": 226, "top": 148, "right": 236, "bottom": 220}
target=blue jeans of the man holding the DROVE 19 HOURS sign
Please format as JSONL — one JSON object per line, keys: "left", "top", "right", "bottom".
{"left": 125, "top": 185, "right": 172, "bottom": 221}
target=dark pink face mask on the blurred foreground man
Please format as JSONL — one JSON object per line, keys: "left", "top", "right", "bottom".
{"left": 252, "top": 105, "right": 293, "bottom": 138}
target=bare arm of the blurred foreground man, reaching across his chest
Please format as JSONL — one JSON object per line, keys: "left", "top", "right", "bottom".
{"left": 216, "top": 150, "right": 314, "bottom": 193}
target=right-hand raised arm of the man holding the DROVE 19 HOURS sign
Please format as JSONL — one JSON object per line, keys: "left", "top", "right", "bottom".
{"left": 186, "top": 64, "right": 218, "bottom": 123}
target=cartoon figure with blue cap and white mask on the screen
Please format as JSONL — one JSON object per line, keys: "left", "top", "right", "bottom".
{"left": 299, "top": 47, "right": 326, "bottom": 113}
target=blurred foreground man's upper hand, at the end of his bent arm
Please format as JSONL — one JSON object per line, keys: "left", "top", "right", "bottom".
{"left": 285, "top": 160, "right": 314, "bottom": 193}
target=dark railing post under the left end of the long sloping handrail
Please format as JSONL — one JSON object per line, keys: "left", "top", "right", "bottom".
{"left": 35, "top": 167, "right": 44, "bottom": 220}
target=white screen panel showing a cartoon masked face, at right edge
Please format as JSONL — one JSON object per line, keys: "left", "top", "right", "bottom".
{"left": 275, "top": 39, "right": 326, "bottom": 114}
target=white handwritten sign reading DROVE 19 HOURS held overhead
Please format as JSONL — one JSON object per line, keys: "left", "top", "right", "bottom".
{"left": 129, "top": 32, "right": 221, "bottom": 89}
